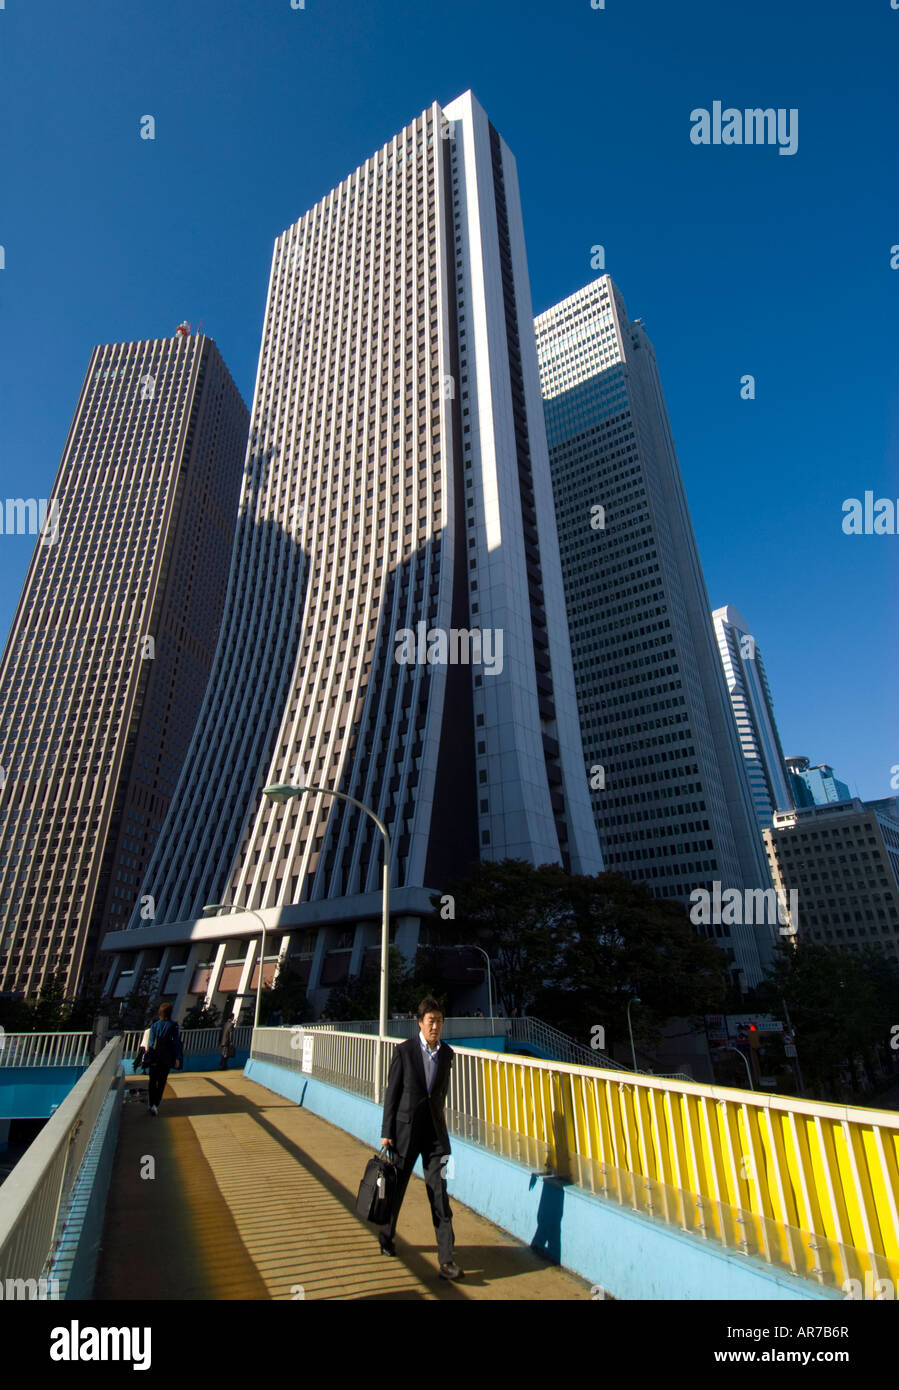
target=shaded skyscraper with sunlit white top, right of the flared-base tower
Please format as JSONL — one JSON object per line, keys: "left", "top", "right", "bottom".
{"left": 536, "top": 275, "right": 773, "bottom": 984}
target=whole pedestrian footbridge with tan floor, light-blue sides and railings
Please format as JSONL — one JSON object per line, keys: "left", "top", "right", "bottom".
{"left": 0, "top": 1020, "right": 899, "bottom": 1300}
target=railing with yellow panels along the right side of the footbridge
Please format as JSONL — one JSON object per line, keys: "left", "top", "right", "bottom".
{"left": 253, "top": 1029, "right": 899, "bottom": 1290}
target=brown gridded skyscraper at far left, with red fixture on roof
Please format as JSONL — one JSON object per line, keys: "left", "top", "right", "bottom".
{"left": 0, "top": 336, "right": 249, "bottom": 994}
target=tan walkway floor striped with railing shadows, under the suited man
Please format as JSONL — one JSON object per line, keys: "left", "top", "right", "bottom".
{"left": 94, "top": 1070, "right": 591, "bottom": 1301}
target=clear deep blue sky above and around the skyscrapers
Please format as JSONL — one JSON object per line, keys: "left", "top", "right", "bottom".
{"left": 0, "top": 0, "right": 899, "bottom": 796}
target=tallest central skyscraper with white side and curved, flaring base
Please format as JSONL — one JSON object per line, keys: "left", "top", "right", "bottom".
{"left": 107, "top": 93, "right": 602, "bottom": 1005}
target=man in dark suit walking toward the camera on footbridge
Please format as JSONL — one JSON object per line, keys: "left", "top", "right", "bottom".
{"left": 378, "top": 997, "right": 463, "bottom": 1279}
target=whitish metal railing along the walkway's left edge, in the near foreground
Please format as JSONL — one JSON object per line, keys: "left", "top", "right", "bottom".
{"left": 0, "top": 1034, "right": 122, "bottom": 1279}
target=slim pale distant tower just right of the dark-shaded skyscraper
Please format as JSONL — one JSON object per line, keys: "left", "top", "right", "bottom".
{"left": 711, "top": 606, "right": 793, "bottom": 830}
